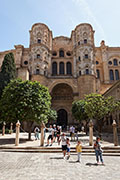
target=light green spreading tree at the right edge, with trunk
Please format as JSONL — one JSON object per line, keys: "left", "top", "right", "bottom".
{"left": 85, "top": 93, "right": 120, "bottom": 132}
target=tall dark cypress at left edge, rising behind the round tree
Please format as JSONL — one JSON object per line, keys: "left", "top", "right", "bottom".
{"left": 0, "top": 53, "right": 16, "bottom": 97}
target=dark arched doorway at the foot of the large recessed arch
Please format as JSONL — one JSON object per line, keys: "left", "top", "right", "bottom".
{"left": 57, "top": 109, "right": 68, "bottom": 128}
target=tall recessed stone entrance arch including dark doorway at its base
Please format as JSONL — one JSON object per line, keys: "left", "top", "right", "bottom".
{"left": 51, "top": 83, "right": 73, "bottom": 127}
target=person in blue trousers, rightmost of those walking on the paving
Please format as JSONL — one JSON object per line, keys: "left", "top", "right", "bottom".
{"left": 94, "top": 137, "right": 104, "bottom": 164}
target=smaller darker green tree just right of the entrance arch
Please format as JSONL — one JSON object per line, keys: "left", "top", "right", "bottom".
{"left": 72, "top": 99, "right": 89, "bottom": 134}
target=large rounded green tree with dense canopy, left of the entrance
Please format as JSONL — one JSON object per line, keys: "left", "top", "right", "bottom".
{"left": 0, "top": 79, "right": 51, "bottom": 139}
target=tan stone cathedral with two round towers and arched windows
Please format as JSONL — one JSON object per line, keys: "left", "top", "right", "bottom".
{"left": 0, "top": 23, "right": 120, "bottom": 125}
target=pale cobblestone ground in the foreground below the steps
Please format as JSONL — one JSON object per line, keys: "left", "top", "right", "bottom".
{"left": 0, "top": 152, "right": 120, "bottom": 180}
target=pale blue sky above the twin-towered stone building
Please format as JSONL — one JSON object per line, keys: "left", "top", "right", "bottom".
{"left": 0, "top": 0, "right": 120, "bottom": 51}
